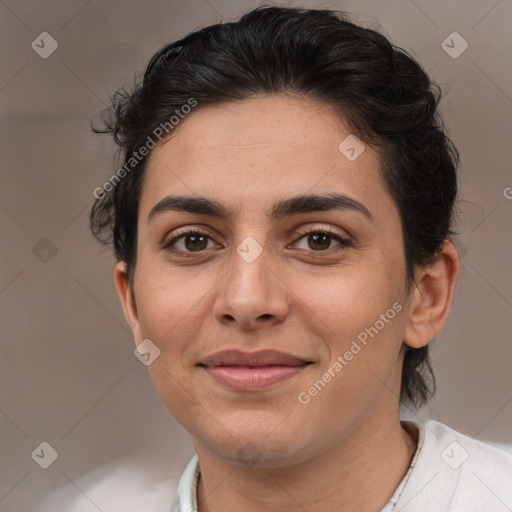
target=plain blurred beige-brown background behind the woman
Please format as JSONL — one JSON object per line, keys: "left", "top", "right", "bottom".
{"left": 0, "top": 0, "right": 512, "bottom": 512}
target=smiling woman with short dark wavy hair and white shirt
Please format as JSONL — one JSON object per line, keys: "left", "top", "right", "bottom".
{"left": 91, "top": 7, "right": 512, "bottom": 512}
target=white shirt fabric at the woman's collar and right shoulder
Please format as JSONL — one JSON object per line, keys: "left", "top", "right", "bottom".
{"left": 172, "top": 420, "right": 512, "bottom": 512}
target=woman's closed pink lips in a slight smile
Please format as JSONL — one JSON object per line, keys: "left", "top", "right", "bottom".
{"left": 200, "top": 350, "right": 310, "bottom": 391}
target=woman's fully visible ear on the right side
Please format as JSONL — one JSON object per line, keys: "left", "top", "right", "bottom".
{"left": 404, "top": 240, "right": 460, "bottom": 348}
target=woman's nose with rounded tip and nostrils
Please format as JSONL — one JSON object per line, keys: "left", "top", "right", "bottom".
{"left": 213, "top": 244, "right": 290, "bottom": 331}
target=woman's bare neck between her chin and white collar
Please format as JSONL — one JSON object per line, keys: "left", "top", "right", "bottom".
{"left": 196, "top": 413, "right": 417, "bottom": 512}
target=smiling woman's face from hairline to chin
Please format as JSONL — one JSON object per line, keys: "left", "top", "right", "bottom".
{"left": 118, "top": 96, "right": 420, "bottom": 467}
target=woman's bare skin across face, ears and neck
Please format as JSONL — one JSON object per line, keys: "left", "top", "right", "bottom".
{"left": 114, "top": 95, "right": 459, "bottom": 512}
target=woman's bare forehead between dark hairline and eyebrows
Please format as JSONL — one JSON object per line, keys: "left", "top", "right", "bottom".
{"left": 140, "top": 95, "right": 392, "bottom": 221}
